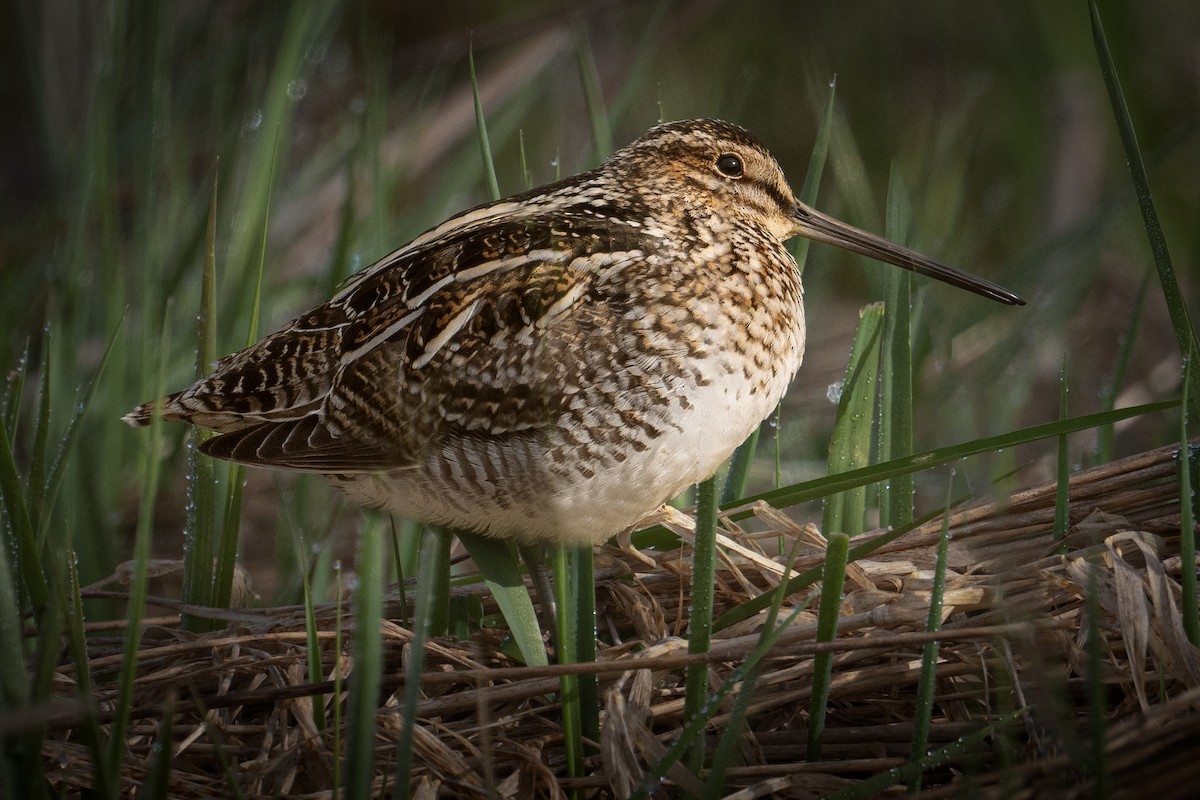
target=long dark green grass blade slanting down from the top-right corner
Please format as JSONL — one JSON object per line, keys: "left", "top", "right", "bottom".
{"left": 1087, "top": 0, "right": 1200, "bottom": 403}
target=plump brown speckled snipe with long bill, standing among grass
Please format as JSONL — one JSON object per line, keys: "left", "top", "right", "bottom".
{"left": 124, "top": 119, "right": 1025, "bottom": 545}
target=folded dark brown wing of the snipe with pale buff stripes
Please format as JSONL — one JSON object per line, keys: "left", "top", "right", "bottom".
{"left": 188, "top": 212, "right": 649, "bottom": 473}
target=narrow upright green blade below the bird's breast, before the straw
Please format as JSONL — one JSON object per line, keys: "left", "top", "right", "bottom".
{"left": 684, "top": 477, "right": 716, "bottom": 775}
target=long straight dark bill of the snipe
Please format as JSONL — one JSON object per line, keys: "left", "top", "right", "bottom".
{"left": 792, "top": 203, "right": 1025, "bottom": 306}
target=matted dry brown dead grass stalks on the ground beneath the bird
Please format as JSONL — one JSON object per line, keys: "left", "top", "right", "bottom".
{"left": 32, "top": 441, "right": 1200, "bottom": 800}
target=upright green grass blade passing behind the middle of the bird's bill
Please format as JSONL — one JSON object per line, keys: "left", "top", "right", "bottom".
{"left": 880, "top": 162, "right": 913, "bottom": 528}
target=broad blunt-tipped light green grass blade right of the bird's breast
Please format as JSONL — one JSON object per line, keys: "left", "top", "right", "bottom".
{"left": 822, "top": 303, "right": 883, "bottom": 535}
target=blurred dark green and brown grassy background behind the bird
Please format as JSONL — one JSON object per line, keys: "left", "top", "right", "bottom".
{"left": 0, "top": 0, "right": 1200, "bottom": 601}
